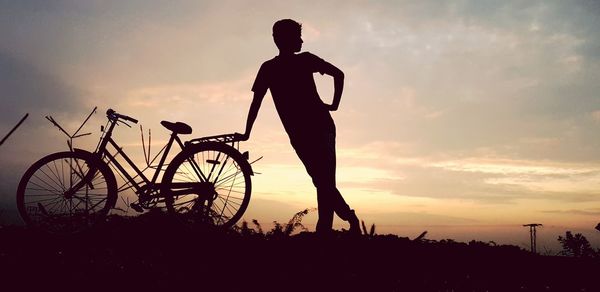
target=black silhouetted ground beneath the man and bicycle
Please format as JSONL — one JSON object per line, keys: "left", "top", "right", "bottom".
{"left": 0, "top": 213, "right": 600, "bottom": 291}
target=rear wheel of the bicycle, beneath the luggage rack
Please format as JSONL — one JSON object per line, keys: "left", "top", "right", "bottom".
{"left": 161, "top": 142, "right": 252, "bottom": 228}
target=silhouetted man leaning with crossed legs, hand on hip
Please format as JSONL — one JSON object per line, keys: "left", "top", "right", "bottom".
{"left": 242, "top": 19, "right": 360, "bottom": 234}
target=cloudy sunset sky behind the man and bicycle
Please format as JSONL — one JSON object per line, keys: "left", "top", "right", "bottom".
{"left": 0, "top": 0, "right": 600, "bottom": 249}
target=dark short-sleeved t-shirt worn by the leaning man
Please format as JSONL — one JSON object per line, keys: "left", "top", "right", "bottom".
{"left": 252, "top": 52, "right": 335, "bottom": 139}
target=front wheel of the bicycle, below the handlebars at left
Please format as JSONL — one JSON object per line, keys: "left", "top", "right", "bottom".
{"left": 17, "top": 150, "right": 117, "bottom": 233}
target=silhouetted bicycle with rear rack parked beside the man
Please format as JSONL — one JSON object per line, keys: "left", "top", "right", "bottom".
{"left": 17, "top": 109, "right": 254, "bottom": 232}
